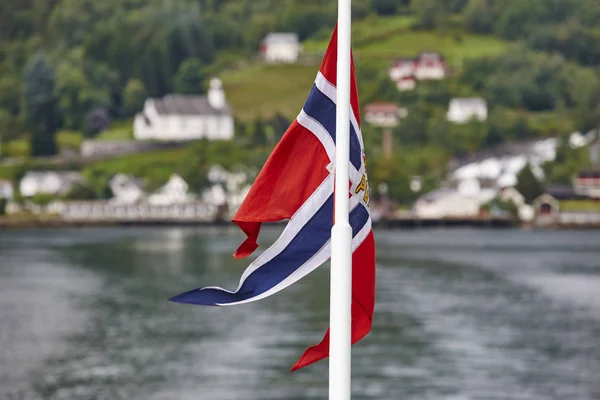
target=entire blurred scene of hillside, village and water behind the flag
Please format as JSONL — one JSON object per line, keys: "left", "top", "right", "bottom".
{"left": 0, "top": 0, "right": 600, "bottom": 400}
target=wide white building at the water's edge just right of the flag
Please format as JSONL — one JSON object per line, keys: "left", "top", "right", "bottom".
{"left": 412, "top": 188, "right": 480, "bottom": 219}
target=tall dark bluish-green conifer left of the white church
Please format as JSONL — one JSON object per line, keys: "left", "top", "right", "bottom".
{"left": 25, "top": 54, "right": 59, "bottom": 156}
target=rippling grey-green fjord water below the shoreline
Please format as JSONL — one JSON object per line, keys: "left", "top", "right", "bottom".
{"left": 0, "top": 228, "right": 600, "bottom": 400}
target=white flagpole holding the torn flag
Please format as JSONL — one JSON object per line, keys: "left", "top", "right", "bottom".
{"left": 329, "top": 0, "right": 352, "bottom": 400}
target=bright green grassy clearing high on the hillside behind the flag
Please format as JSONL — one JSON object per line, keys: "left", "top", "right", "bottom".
{"left": 221, "top": 16, "right": 509, "bottom": 121}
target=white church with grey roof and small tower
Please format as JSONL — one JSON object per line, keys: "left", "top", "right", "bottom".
{"left": 133, "top": 78, "right": 234, "bottom": 141}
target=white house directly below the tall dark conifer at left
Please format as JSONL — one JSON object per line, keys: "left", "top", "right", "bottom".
{"left": 19, "top": 171, "right": 84, "bottom": 197}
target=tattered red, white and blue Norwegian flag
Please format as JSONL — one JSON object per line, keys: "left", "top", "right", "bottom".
{"left": 170, "top": 27, "right": 375, "bottom": 370}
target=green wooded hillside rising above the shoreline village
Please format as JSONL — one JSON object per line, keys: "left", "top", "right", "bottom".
{"left": 0, "top": 0, "right": 600, "bottom": 202}
